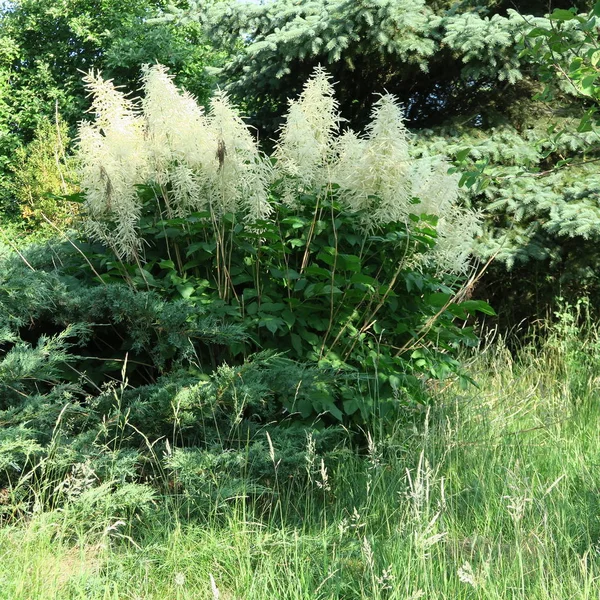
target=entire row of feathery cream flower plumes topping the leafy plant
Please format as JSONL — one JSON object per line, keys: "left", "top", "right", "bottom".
{"left": 78, "top": 65, "right": 479, "bottom": 272}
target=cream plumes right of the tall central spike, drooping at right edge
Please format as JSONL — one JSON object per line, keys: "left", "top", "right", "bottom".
{"left": 334, "top": 94, "right": 481, "bottom": 274}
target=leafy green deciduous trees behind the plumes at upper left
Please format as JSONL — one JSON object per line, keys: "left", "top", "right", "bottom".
{"left": 0, "top": 0, "right": 219, "bottom": 220}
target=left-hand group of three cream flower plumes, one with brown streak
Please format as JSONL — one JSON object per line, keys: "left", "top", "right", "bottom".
{"left": 78, "top": 65, "right": 272, "bottom": 258}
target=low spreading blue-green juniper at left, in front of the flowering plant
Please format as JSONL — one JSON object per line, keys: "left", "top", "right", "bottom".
{"left": 0, "top": 239, "right": 352, "bottom": 522}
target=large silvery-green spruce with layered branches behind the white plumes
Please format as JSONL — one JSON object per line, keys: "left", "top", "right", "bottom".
{"left": 166, "top": 0, "right": 600, "bottom": 323}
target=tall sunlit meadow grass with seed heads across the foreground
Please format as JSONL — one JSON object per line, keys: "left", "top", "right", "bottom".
{"left": 0, "top": 319, "right": 600, "bottom": 600}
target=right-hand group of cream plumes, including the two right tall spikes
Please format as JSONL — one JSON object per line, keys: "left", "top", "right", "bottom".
{"left": 275, "top": 68, "right": 481, "bottom": 273}
